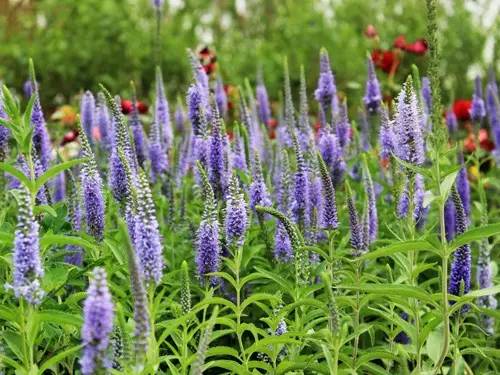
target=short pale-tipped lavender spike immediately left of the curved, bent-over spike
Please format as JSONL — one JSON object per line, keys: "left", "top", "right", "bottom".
{"left": 224, "top": 175, "right": 248, "bottom": 246}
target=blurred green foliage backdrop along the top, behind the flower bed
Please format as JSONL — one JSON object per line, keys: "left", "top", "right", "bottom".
{"left": 0, "top": 0, "right": 500, "bottom": 107}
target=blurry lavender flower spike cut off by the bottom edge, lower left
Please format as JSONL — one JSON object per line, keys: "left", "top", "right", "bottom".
{"left": 80, "top": 267, "right": 114, "bottom": 375}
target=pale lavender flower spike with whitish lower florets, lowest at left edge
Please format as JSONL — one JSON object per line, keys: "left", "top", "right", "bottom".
{"left": 12, "top": 188, "right": 44, "bottom": 305}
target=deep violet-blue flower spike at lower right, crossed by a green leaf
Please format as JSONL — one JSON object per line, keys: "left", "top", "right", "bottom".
{"left": 448, "top": 188, "right": 472, "bottom": 312}
